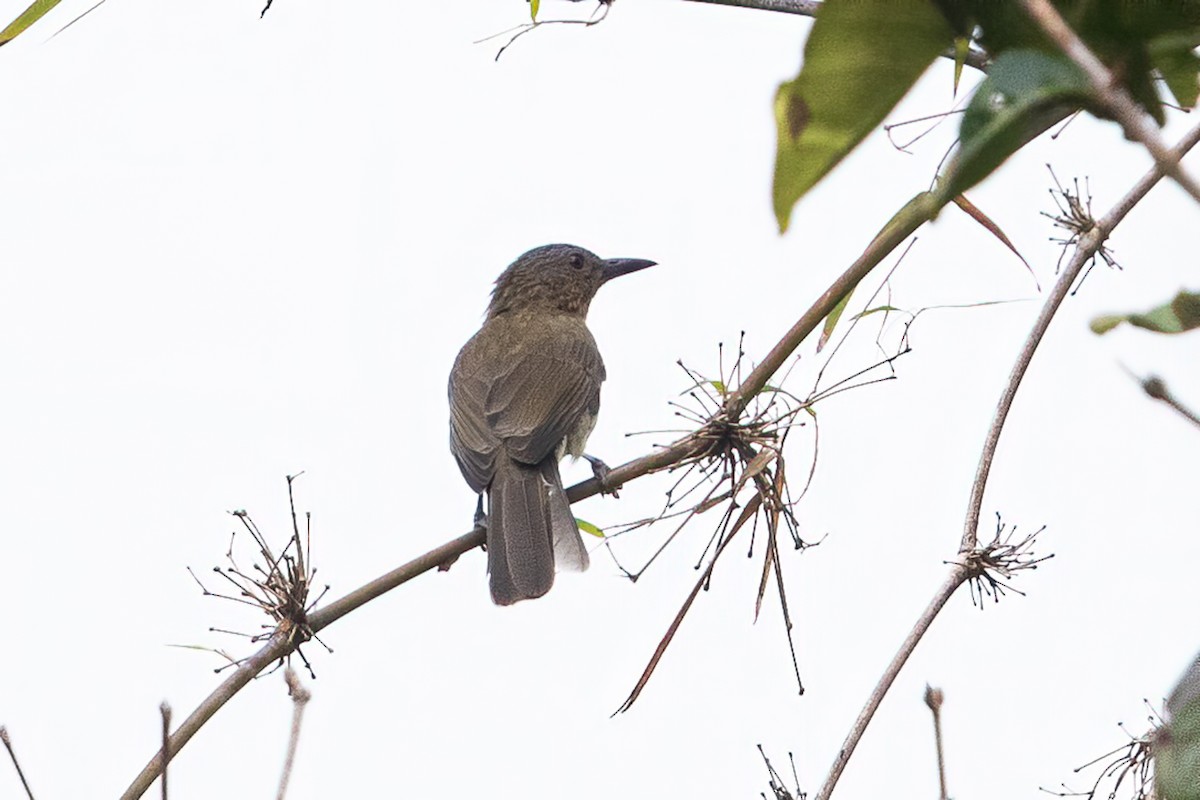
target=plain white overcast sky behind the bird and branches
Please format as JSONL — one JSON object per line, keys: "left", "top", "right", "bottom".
{"left": 0, "top": 0, "right": 1200, "bottom": 800}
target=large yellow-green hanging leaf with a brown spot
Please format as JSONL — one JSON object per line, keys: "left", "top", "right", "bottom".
{"left": 773, "top": 0, "right": 954, "bottom": 231}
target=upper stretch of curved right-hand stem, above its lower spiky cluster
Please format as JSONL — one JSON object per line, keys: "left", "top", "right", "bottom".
{"left": 959, "top": 125, "right": 1200, "bottom": 552}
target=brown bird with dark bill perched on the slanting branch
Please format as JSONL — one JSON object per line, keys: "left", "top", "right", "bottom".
{"left": 449, "top": 245, "right": 655, "bottom": 606}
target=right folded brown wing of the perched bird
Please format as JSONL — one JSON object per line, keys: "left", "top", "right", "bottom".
{"left": 484, "top": 320, "right": 605, "bottom": 464}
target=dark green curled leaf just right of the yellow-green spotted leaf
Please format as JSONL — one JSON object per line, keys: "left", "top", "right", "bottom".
{"left": 937, "top": 49, "right": 1092, "bottom": 204}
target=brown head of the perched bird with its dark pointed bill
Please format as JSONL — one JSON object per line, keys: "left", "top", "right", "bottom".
{"left": 487, "top": 245, "right": 654, "bottom": 318}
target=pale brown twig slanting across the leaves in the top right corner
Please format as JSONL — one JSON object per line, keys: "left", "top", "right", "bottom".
{"left": 1021, "top": 0, "right": 1200, "bottom": 203}
